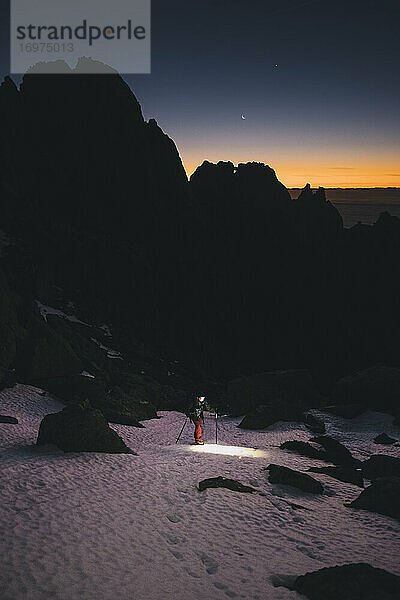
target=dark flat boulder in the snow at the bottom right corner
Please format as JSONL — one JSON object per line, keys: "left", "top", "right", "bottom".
{"left": 293, "top": 563, "right": 400, "bottom": 600}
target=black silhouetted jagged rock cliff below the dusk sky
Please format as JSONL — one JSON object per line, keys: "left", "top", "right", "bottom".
{"left": 0, "top": 75, "right": 400, "bottom": 390}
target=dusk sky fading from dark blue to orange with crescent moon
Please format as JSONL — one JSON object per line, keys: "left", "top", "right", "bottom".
{"left": 0, "top": 0, "right": 400, "bottom": 187}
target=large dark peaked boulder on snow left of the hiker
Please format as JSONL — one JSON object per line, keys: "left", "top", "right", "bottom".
{"left": 37, "top": 401, "right": 135, "bottom": 454}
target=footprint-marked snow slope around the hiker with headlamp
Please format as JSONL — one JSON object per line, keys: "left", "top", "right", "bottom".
{"left": 0, "top": 385, "right": 400, "bottom": 600}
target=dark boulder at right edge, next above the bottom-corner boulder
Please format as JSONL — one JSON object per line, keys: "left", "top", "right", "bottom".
{"left": 345, "top": 477, "right": 400, "bottom": 521}
